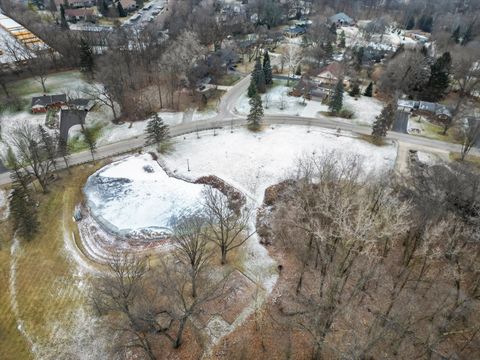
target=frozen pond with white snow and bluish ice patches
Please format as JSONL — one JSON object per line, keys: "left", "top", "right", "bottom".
{"left": 84, "top": 154, "right": 211, "bottom": 236}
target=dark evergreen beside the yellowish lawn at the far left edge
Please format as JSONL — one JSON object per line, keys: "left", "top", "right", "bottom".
{"left": 9, "top": 184, "right": 39, "bottom": 240}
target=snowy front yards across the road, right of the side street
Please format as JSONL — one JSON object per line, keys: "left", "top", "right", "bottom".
{"left": 235, "top": 83, "right": 383, "bottom": 125}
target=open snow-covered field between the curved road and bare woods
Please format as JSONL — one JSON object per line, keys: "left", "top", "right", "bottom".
{"left": 164, "top": 126, "right": 396, "bottom": 203}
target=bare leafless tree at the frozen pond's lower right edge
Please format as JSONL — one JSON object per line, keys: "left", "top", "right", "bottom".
{"left": 203, "top": 187, "right": 255, "bottom": 265}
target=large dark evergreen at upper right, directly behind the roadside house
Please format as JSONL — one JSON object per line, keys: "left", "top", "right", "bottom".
{"left": 422, "top": 52, "right": 452, "bottom": 102}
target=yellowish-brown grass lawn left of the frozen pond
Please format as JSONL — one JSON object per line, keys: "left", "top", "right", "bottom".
{"left": 0, "top": 164, "right": 104, "bottom": 360}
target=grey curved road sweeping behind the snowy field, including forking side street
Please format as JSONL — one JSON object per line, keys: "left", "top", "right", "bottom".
{"left": 0, "top": 76, "right": 479, "bottom": 185}
